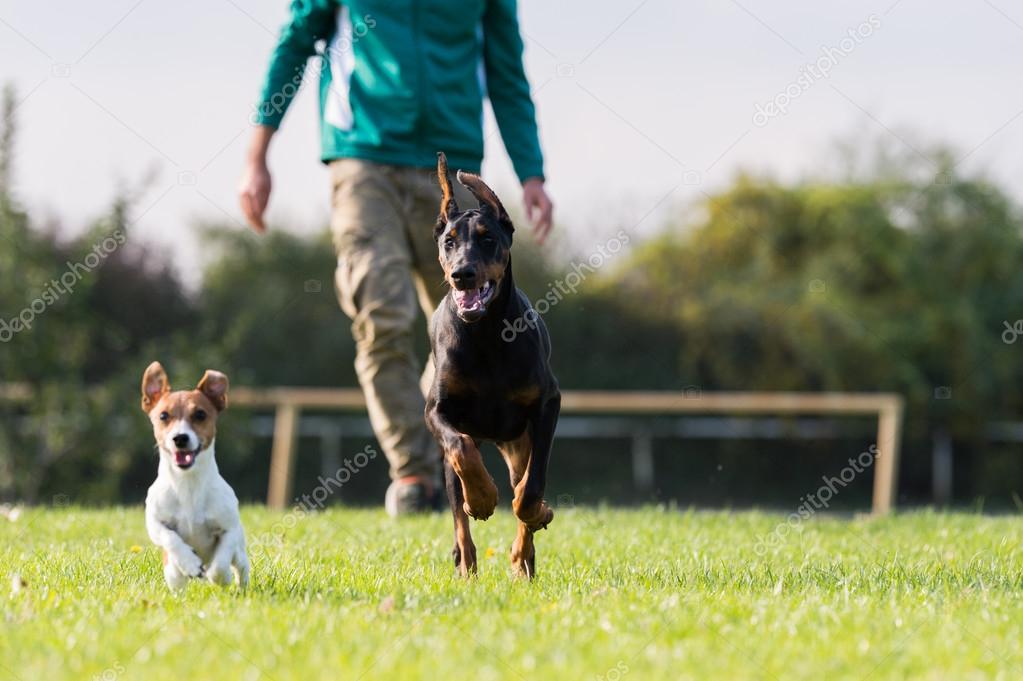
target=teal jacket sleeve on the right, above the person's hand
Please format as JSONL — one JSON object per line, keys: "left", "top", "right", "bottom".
{"left": 483, "top": 0, "right": 543, "bottom": 181}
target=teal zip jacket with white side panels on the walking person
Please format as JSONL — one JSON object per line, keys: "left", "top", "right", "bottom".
{"left": 253, "top": 0, "right": 543, "bottom": 180}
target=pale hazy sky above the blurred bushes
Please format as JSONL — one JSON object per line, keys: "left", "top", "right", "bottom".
{"left": 0, "top": 0, "right": 1023, "bottom": 285}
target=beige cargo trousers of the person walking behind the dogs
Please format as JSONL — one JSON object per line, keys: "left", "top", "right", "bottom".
{"left": 330, "top": 158, "right": 468, "bottom": 482}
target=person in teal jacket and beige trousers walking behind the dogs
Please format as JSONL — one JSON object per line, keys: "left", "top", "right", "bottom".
{"left": 238, "top": 0, "right": 552, "bottom": 515}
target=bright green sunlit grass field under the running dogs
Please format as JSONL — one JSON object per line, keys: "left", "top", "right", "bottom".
{"left": 0, "top": 507, "right": 1023, "bottom": 681}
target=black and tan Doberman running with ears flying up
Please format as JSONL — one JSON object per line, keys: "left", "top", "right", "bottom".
{"left": 426, "top": 153, "right": 562, "bottom": 579}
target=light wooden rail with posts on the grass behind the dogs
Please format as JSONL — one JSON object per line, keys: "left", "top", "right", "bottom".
{"left": 0, "top": 383, "right": 903, "bottom": 515}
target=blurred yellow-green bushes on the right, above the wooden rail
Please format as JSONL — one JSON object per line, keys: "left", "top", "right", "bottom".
{"left": 605, "top": 153, "right": 1023, "bottom": 440}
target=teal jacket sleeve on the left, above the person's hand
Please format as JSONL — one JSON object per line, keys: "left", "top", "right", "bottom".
{"left": 252, "top": 0, "right": 338, "bottom": 128}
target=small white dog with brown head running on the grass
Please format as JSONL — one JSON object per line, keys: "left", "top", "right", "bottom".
{"left": 142, "top": 362, "right": 249, "bottom": 589}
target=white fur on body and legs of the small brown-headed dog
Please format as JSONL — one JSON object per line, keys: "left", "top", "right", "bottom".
{"left": 145, "top": 437, "right": 249, "bottom": 590}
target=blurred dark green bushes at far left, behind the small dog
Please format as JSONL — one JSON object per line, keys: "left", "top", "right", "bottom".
{"left": 0, "top": 90, "right": 197, "bottom": 502}
